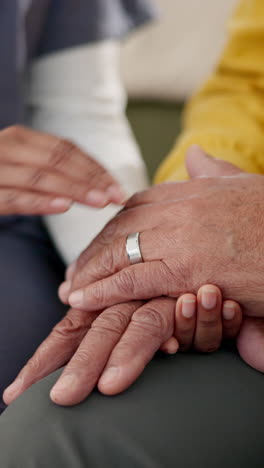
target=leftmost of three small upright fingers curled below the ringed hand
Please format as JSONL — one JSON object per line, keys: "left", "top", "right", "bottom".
{"left": 175, "top": 294, "right": 197, "bottom": 351}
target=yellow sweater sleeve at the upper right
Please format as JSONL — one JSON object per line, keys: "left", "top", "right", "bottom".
{"left": 155, "top": 0, "right": 264, "bottom": 182}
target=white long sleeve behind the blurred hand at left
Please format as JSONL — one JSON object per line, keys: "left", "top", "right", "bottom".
{"left": 28, "top": 41, "right": 148, "bottom": 263}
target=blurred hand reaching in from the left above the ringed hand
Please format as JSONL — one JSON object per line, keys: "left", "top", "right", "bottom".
{"left": 0, "top": 126, "right": 124, "bottom": 215}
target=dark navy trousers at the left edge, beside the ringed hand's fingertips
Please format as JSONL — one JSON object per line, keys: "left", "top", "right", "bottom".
{"left": 0, "top": 216, "right": 67, "bottom": 413}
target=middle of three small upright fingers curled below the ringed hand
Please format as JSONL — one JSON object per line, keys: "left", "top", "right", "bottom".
{"left": 194, "top": 285, "right": 222, "bottom": 353}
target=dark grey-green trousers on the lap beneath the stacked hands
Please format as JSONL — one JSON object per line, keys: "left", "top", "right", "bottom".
{"left": 0, "top": 349, "right": 264, "bottom": 468}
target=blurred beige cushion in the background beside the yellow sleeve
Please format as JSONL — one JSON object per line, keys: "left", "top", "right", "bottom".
{"left": 122, "top": 0, "right": 237, "bottom": 100}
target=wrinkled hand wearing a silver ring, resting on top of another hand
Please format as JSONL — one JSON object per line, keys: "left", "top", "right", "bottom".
{"left": 61, "top": 148, "right": 264, "bottom": 317}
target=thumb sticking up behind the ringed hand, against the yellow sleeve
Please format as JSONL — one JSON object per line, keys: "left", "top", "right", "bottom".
{"left": 186, "top": 145, "right": 244, "bottom": 178}
